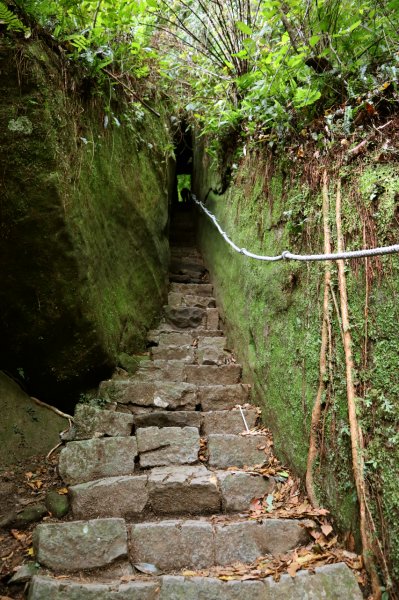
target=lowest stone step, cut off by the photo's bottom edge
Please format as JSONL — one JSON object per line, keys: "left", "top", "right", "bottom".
{"left": 29, "top": 563, "right": 363, "bottom": 600}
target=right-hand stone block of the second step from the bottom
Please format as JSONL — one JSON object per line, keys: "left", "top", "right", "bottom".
{"left": 215, "top": 519, "right": 308, "bottom": 565}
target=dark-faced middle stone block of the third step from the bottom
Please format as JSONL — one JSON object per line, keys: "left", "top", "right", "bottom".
{"left": 148, "top": 465, "right": 221, "bottom": 515}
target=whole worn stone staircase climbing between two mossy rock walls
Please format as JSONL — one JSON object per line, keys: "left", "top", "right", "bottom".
{"left": 29, "top": 215, "right": 362, "bottom": 600}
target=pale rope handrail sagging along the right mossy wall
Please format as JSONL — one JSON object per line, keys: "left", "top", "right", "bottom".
{"left": 191, "top": 194, "right": 399, "bottom": 262}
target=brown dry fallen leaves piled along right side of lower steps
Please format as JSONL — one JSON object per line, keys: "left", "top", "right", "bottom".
{"left": 193, "top": 427, "right": 367, "bottom": 586}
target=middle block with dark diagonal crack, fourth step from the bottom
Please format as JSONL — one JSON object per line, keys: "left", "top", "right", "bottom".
{"left": 137, "top": 427, "right": 200, "bottom": 467}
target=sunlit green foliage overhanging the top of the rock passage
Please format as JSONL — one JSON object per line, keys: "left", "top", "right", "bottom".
{"left": 0, "top": 0, "right": 399, "bottom": 140}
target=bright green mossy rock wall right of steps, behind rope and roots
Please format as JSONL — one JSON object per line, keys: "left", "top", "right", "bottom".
{"left": 194, "top": 139, "right": 399, "bottom": 579}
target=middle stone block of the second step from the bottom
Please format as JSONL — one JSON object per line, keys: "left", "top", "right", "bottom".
{"left": 130, "top": 521, "right": 215, "bottom": 571}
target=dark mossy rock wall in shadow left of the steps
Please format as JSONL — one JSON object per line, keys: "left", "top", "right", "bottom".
{"left": 0, "top": 38, "right": 174, "bottom": 402}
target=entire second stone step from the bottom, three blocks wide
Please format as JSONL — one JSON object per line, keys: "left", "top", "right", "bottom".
{"left": 34, "top": 518, "right": 309, "bottom": 572}
